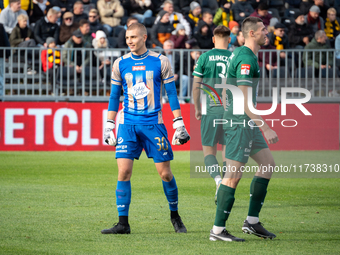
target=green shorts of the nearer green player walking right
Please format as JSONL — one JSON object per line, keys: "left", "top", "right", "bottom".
{"left": 225, "top": 126, "right": 268, "bottom": 163}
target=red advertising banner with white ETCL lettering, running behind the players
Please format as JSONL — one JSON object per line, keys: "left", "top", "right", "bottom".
{"left": 0, "top": 102, "right": 339, "bottom": 151}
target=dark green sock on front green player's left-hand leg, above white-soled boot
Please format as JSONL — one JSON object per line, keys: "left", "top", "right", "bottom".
{"left": 214, "top": 184, "right": 235, "bottom": 227}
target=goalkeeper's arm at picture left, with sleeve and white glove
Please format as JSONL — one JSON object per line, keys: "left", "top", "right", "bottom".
{"left": 104, "top": 59, "right": 122, "bottom": 146}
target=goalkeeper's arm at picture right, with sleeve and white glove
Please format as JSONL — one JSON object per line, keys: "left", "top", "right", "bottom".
{"left": 161, "top": 56, "right": 190, "bottom": 145}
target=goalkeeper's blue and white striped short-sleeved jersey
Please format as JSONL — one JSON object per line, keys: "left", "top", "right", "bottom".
{"left": 111, "top": 50, "right": 174, "bottom": 124}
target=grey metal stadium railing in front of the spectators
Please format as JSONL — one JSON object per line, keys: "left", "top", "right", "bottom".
{"left": 0, "top": 47, "right": 340, "bottom": 102}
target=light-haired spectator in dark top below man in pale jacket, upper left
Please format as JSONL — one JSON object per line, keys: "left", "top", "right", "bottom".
{"left": 9, "top": 14, "right": 36, "bottom": 47}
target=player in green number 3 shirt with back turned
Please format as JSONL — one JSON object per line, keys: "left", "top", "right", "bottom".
{"left": 193, "top": 26, "right": 231, "bottom": 203}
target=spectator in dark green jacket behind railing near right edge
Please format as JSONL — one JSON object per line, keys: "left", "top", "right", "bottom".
{"left": 302, "top": 30, "right": 333, "bottom": 77}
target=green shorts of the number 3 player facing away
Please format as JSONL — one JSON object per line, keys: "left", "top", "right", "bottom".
{"left": 201, "top": 114, "right": 225, "bottom": 146}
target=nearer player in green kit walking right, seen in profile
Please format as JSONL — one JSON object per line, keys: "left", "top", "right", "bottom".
{"left": 210, "top": 17, "right": 278, "bottom": 241}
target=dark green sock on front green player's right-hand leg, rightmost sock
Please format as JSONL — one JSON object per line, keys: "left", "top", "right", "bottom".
{"left": 248, "top": 176, "right": 269, "bottom": 217}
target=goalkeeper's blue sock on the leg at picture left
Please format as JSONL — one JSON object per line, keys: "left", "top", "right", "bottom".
{"left": 116, "top": 181, "right": 131, "bottom": 216}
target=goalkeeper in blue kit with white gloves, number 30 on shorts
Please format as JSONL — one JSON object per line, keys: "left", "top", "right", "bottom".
{"left": 102, "top": 23, "right": 190, "bottom": 234}
